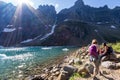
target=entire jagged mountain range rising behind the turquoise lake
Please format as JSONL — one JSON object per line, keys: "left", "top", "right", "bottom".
{"left": 0, "top": 0, "right": 120, "bottom": 46}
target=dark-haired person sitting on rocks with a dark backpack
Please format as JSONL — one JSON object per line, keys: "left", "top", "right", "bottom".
{"left": 100, "top": 43, "right": 113, "bottom": 59}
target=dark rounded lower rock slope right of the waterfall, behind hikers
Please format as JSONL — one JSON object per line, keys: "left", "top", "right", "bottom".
{"left": 41, "top": 21, "right": 120, "bottom": 46}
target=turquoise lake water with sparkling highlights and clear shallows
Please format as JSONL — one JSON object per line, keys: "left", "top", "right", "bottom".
{"left": 0, "top": 47, "right": 78, "bottom": 80}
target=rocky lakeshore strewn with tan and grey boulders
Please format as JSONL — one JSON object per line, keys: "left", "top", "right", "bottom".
{"left": 25, "top": 47, "right": 120, "bottom": 80}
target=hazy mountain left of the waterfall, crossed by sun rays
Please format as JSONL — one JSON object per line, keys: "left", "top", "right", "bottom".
{"left": 0, "top": 2, "right": 56, "bottom": 46}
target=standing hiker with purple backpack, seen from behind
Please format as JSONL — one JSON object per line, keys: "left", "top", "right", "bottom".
{"left": 88, "top": 39, "right": 100, "bottom": 78}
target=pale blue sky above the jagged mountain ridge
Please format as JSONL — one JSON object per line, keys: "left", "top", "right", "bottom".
{"left": 0, "top": 0, "right": 120, "bottom": 12}
